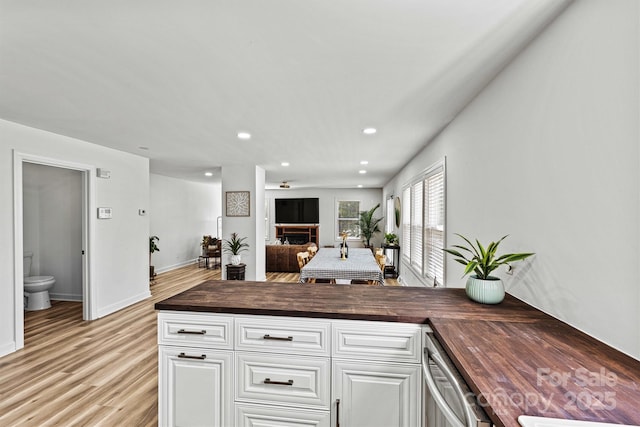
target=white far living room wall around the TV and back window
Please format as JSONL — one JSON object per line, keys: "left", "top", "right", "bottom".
{"left": 265, "top": 188, "right": 385, "bottom": 246}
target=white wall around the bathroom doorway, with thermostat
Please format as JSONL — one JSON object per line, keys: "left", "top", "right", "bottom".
{"left": 0, "top": 120, "right": 150, "bottom": 355}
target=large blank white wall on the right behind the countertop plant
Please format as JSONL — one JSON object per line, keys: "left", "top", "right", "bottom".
{"left": 384, "top": 0, "right": 640, "bottom": 358}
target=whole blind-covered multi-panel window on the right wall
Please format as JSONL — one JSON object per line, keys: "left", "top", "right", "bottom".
{"left": 402, "top": 160, "right": 445, "bottom": 284}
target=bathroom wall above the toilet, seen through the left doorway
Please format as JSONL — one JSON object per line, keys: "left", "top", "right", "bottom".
{"left": 22, "top": 163, "right": 82, "bottom": 301}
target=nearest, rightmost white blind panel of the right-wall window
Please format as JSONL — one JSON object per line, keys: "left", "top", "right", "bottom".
{"left": 424, "top": 166, "right": 445, "bottom": 285}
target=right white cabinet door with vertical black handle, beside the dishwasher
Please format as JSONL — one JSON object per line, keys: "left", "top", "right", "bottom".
{"left": 331, "top": 360, "right": 422, "bottom": 427}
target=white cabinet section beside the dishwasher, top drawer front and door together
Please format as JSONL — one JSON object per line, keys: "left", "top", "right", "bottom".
{"left": 331, "top": 320, "right": 423, "bottom": 427}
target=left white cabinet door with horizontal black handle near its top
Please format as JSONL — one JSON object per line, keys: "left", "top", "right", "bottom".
{"left": 158, "top": 346, "right": 233, "bottom": 427}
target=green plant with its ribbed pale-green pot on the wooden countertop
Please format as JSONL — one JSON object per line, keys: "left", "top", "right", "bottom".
{"left": 443, "top": 233, "right": 534, "bottom": 304}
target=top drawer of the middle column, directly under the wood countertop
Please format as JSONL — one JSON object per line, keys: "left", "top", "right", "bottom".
{"left": 235, "top": 316, "right": 331, "bottom": 357}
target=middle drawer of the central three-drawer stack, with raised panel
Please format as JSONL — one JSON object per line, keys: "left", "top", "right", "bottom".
{"left": 236, "top": 353, "right": 331, "bottom": 409}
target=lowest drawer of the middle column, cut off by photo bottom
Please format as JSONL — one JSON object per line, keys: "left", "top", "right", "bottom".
{"left": 236, "top": 404, "right": 331, "bottom": 427}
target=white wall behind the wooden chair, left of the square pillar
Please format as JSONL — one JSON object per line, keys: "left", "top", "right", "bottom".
{"left": 148, "top": 174, "right": 222, "bottom": 272}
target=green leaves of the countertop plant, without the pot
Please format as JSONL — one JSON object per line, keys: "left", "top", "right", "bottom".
{"left": 443, "top": 233, "right": 535, "bottom": 280}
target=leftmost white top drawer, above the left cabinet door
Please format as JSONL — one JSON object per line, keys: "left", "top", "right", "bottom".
{"left": 158, "top": 312, "right": 233, "bottom": 349}
